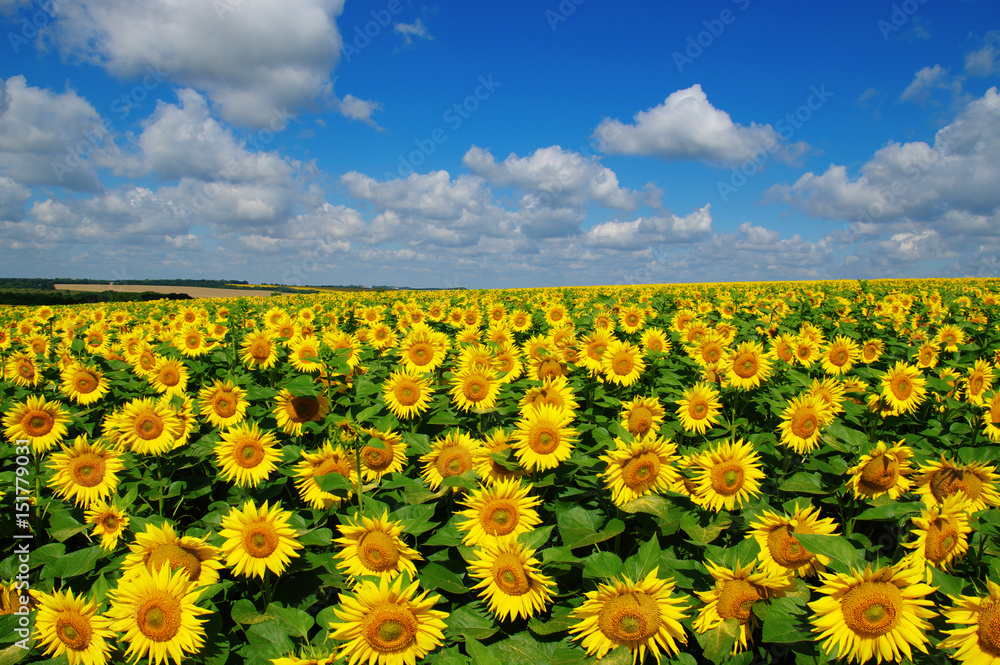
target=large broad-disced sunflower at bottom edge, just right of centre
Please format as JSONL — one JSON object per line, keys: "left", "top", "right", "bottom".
{"left": 569, "top": 568, "right": 689, "bottom": 663}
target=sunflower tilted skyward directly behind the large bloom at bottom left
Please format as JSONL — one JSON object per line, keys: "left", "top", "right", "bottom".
{"left": 122, "top": 522, "right": 222, "bottom": 587}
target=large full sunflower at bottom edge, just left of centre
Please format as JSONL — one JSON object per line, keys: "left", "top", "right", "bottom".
{"left": 330, "top": 575, "right": 448, "bottom": 665}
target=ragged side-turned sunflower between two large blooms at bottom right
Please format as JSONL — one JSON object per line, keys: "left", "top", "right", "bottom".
{"left": 691, "top": 561, "right": 791, "bottom": 654}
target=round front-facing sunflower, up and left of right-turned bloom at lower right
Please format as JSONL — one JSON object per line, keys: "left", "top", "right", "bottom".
{"left": 696, "top": 439, "right": 764, "bottom": 512}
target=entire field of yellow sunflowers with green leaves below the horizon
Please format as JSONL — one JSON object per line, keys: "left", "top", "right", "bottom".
{"left": 0, "top": 279, "right": 1000, "bottom": 665}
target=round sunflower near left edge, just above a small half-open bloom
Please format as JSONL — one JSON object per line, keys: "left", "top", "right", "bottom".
{"left": 46, "top": 435, "right": 123, "bottom": 508}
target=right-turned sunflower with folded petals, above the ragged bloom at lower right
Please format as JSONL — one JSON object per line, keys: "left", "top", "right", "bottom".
{"left": 747, "top": 506, "right": 837, "bottom": 577}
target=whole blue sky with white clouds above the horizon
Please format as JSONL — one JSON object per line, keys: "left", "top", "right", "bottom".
{"left": 0, "top": 0, "right": 1000, "bottom": 288}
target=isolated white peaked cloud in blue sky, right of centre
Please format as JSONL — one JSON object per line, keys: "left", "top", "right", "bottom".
{"left": 593, "top": 84, "right": 806, "bottom": 164}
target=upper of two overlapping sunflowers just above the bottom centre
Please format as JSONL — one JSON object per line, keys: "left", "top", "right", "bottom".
{"left": 458, "top": 478, "right": 542, "bottom": 547}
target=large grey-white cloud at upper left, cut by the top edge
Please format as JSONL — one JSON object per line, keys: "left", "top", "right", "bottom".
{"left": 53, "top": 0, "right": 343, "bottom": 127}
